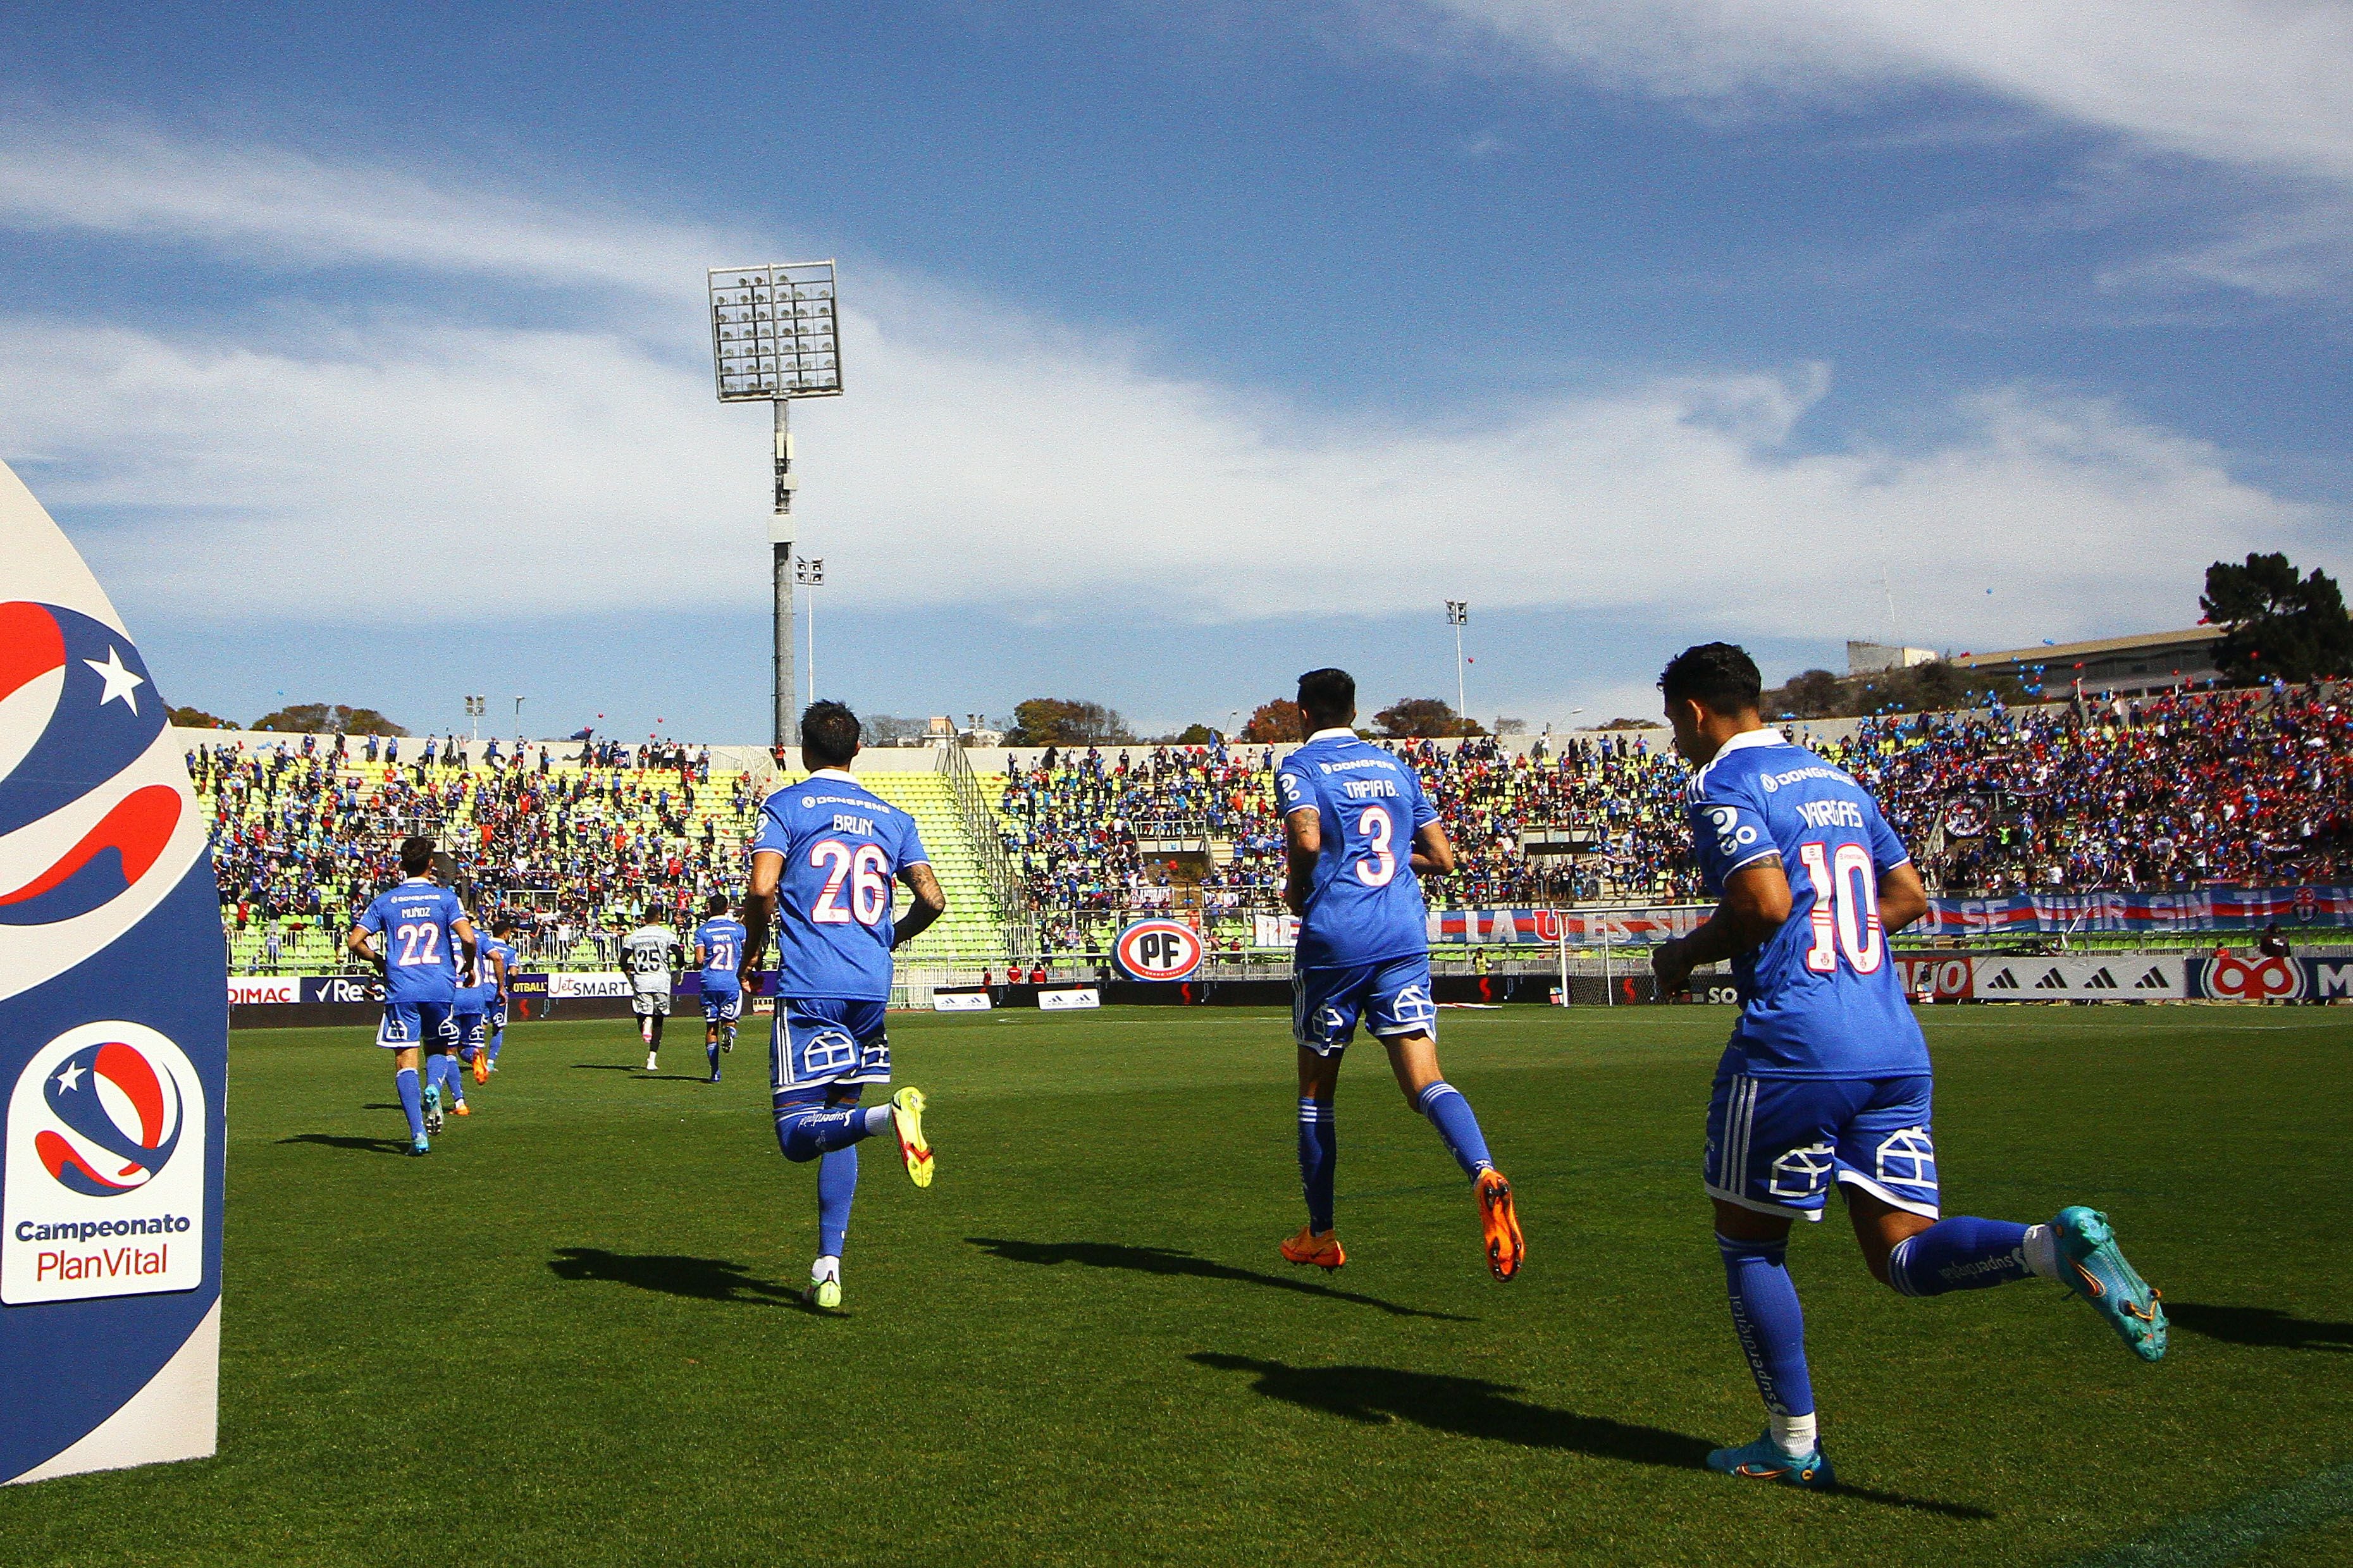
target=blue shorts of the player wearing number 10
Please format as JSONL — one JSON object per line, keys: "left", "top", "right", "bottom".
{"left": 1703, "top": 1064, "right": 1937, "bottom": 1219}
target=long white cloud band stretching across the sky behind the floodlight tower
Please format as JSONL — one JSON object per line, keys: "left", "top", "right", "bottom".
{"left": 0, "top": 122, "right": 2341, "bottom": 645}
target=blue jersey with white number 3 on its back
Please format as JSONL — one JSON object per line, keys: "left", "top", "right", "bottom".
{"left": 1275, "top": 734, "right": 1438, "bottom": 970}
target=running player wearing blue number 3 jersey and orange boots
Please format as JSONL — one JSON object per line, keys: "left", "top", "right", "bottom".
{"left": 1275, "top": 669, "right": 1527, "bottom": 1281}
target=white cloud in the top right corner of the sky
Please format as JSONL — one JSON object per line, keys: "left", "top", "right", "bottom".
{"left": 1419, "top": 0, "right": 2353, "bottom": 183}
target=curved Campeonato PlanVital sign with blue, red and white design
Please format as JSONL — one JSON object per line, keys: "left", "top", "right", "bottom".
{"left": 0, "top": 466, "right": 226, "bottom": 1481}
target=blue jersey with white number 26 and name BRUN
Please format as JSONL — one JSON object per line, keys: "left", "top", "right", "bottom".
{"left": 751, "top": 767, "right": 932, "bottom": 1001}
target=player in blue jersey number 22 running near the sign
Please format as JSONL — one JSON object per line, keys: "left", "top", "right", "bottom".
{"left": 343, "top": 836, "right": 475, "bottom": 1154}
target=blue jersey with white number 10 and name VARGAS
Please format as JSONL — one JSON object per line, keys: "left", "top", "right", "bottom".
{"left": 1689, "top": 730, "right": 1927, "bottom": 1078}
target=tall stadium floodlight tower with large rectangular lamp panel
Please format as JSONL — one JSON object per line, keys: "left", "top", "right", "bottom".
{"left": 710, "top": 261, "right": 843, "bottom": 746}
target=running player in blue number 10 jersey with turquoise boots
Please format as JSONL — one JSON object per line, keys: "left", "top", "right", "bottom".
{"left": 1652, "top": 643, "right": 2165, "bottom": 1488}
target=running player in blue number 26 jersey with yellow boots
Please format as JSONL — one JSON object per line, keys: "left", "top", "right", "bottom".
{"left": 736, "top": 701, "right": 948, "bottom": 1309}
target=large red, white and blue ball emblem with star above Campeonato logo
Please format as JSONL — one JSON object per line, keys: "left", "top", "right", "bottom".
{"left": 0, "top": 600, "right": 188, "bottom": 925}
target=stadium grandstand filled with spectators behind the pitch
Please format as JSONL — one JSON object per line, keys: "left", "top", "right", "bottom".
{"left": 186, "top": 685, "right": 2353, "bottom": 972}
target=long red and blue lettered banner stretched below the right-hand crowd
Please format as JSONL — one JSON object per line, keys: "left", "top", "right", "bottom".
{"left": 1428, "top": 887, "right": 2353, "bottom": 946}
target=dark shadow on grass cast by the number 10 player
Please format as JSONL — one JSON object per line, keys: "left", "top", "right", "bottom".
{"left": 1189, "top": 1352, "right": 1993, "bottom": 1519}
